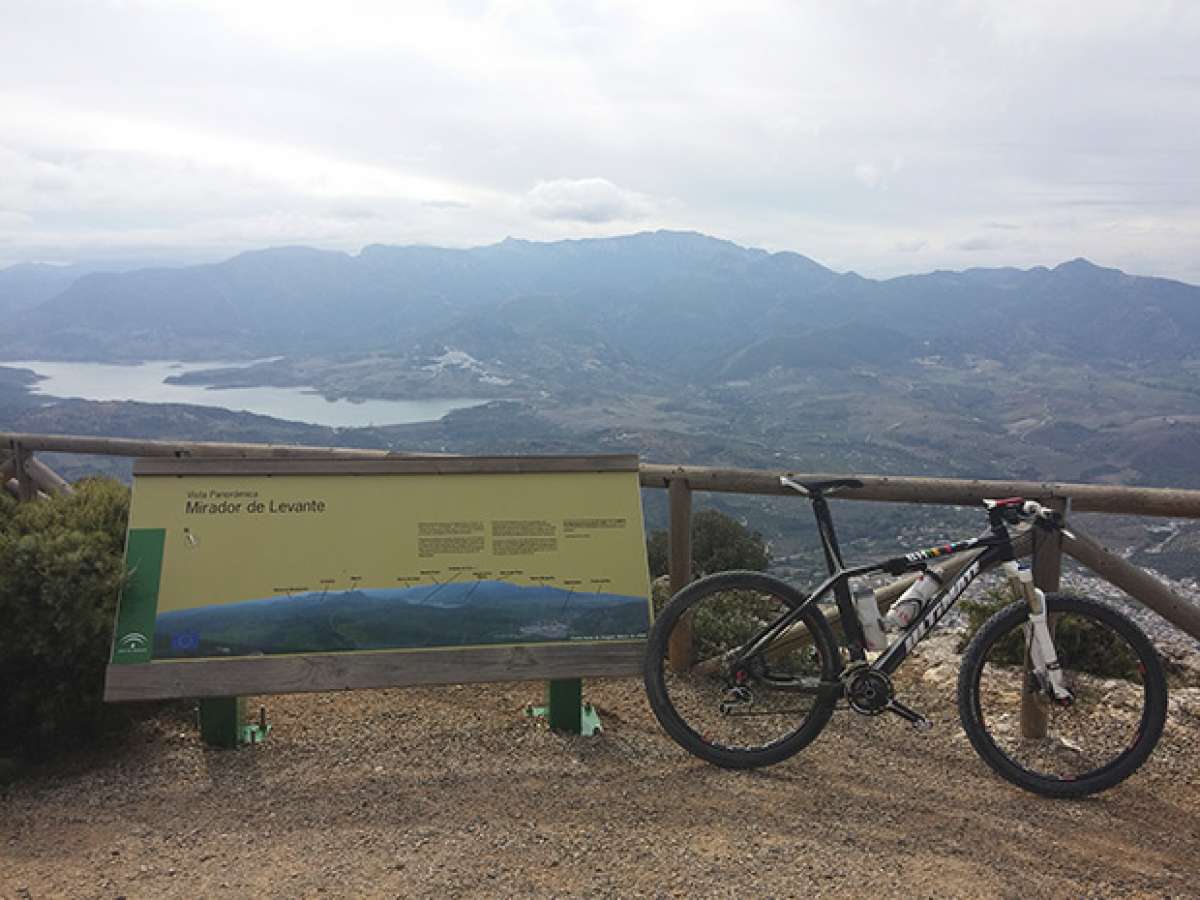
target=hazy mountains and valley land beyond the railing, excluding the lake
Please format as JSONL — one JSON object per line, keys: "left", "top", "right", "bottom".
{"left": 0, "top": 232, "right": 1200, "bottom": 577}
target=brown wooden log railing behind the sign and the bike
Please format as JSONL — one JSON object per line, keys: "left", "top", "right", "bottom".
{"left": 7, "top": 432, "right": 1200, "bottom": 641}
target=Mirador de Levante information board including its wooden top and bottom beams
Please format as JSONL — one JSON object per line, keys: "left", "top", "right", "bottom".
{"left": 106, "top": 456, "right": 649, "bottom": 700}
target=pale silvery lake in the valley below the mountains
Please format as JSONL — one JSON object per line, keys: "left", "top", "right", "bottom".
{"left": 0, "top": 360, "right": 487, "bottom": 428}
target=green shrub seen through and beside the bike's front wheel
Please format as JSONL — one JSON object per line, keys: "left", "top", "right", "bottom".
{"left": 959, "top": 588, "right": 1140, "bottom": 680}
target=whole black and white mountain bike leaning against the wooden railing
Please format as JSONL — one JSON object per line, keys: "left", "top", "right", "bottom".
{"left": 644, "top": 475, "right": 1166, "bottom": 797}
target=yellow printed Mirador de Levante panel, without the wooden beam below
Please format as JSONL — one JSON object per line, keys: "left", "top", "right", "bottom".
{"left": 113, "top": 457, "right": 649, "bottom": 664}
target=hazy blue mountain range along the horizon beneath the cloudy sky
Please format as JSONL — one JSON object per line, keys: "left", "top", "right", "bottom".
{"left": 0, "top": 232, "right": 1200, "bottom": 379}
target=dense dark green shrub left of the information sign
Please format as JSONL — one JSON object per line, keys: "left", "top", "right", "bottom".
{"left": 0, "top": 479, "right": 130, "bottom": 758}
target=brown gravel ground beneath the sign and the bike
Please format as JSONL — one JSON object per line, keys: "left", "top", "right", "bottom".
{"left": 0, "top": 642, "right": 1200, "bottom": 900}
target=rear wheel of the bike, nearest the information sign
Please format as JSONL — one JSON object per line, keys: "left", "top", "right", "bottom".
{"left": 643, "top": 571, "right": 841, "bottom": 768}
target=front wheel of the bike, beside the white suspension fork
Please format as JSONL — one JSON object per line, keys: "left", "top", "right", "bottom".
{"left": 959, "top": 594, "right": 1166, "bottom": 797}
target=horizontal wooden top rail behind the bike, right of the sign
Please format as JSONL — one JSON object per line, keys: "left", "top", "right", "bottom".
{"left": 641, "top": 463, "right": 1200, "bottom": 518}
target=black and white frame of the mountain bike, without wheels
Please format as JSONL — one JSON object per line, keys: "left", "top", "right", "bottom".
{"left": 731, "top": 492, "right": 1013, "bottom": 676}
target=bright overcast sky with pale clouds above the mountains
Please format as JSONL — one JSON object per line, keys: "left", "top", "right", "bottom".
{"left": 0, "top": 0, "right": 1200, "bottom": 283}
